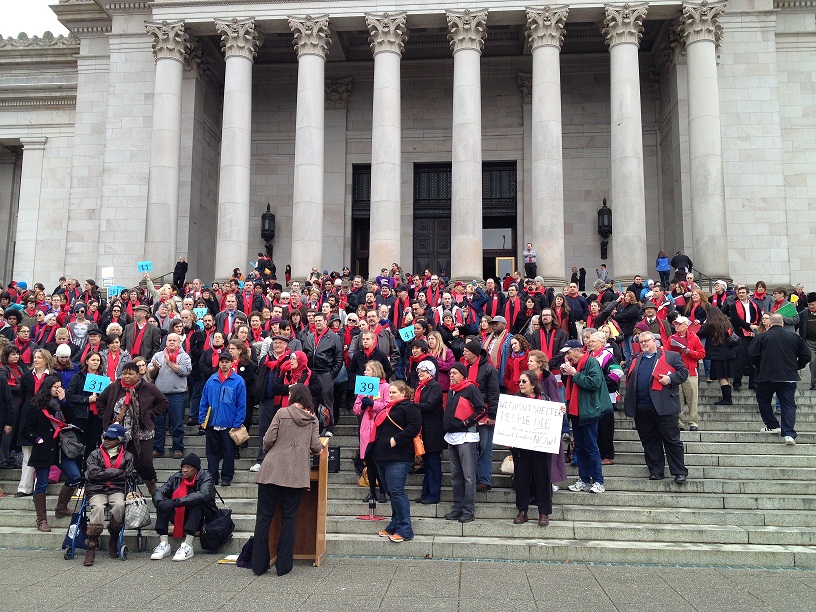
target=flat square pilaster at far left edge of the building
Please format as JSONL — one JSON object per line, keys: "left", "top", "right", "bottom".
{"left": 14, "top": 136, "right": 48, "bottom": 286}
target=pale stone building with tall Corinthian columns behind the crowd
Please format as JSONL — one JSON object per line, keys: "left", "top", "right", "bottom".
{"left": 0, "top": 0, "right": 816, "bottom": 290}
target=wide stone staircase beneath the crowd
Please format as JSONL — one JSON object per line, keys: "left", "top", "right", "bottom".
{"left": 0, "top": 383, "right": 816, "bottom": 568}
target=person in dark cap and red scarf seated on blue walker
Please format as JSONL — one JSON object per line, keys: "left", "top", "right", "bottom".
{"left": 82, "top": 423, "right": 133, "bottom": 566}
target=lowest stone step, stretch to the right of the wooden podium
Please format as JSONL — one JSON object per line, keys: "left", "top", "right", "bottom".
{"left": 327, "top": 527, "right": 816, "bottom": 568}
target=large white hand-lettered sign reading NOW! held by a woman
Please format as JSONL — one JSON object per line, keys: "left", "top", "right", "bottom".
{"left": 493, "top": 394, "right": 564, "bottom": 453}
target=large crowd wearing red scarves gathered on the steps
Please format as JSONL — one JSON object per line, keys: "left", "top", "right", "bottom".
{"left": 0, "top": 243, "right": 816, "bottom": 573}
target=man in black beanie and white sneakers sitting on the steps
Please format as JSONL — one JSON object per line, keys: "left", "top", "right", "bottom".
{"left": 150, "top": 452, "right": 218, "bottom": 561}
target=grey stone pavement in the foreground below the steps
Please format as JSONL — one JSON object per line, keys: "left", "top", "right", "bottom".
{"left": 0, "top": 549, "right": 816, "bottom": 612}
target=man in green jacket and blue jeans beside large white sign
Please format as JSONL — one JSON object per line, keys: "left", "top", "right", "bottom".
{"left": 561, "top": 340, "right": 612, "bottom": 493}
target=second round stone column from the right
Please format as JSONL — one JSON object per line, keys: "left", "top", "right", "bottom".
{"left": 603, "top": 4, "right": 647, "bottom": 281}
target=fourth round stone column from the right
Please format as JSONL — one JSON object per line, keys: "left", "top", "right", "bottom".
{"left": 447, "top": 9, "right": 487, "bottom": 279}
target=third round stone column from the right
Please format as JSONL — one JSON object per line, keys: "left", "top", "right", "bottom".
{"left": 518, "top": 6, "right": 569, "bottom": 286}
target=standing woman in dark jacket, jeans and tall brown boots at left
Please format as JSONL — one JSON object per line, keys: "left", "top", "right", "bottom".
{"left": 20, "top": 376, "right": 82, "bottom": 531}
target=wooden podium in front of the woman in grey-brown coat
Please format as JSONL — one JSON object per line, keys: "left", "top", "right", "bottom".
{"left": 269, "top": 438, "right": 329, "bottom": 567}
